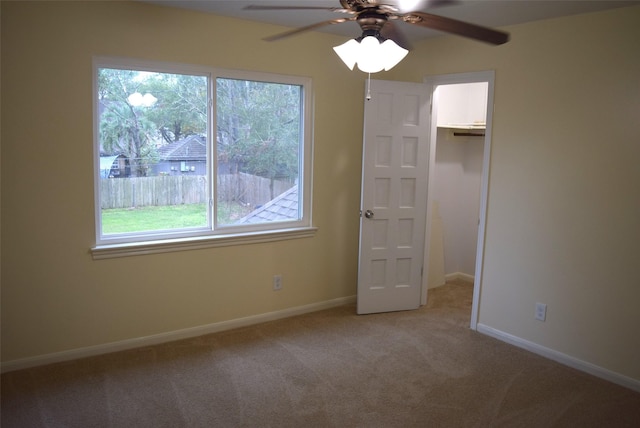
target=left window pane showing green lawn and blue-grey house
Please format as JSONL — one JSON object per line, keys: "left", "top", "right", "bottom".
{"left": 97, "top": 68, "right": 209, "bottom": 235}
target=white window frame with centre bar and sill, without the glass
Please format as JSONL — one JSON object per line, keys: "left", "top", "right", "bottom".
{"left": 91, "top": 57, "right": 316, "bottom": 259}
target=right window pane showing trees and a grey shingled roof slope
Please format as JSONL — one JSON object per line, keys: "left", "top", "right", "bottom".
{"left": 216, "top": 78, "right": 303, "bottom": 226}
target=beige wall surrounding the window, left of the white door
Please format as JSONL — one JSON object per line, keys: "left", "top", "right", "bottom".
{"left": 2, "top": 2, "right": 364, "bottom": 362}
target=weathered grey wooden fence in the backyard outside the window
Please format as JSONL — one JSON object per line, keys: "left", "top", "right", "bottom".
{"left": 100, "top": 173, "right": 294, "bottom": 209}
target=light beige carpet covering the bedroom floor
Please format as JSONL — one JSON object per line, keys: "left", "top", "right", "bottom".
{"left": 2, "top": 283, "right": 640, "bottom": 428}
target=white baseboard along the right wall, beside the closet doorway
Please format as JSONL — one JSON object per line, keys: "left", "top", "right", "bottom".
{"left": 478, "top": 324, "right": 640, "bottom": 392}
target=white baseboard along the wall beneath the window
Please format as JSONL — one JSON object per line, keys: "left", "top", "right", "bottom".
{"left": 2, "top": 296, "right": 356, "bottom": 373}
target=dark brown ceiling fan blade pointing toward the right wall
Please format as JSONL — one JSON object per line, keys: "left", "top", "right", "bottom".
{"left": 401, "top": 12, "right": 509, "bottom": 45}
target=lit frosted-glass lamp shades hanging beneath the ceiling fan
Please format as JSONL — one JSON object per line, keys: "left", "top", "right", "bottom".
{"left": 333, "top": 36, "right": 409, "bottom": 73}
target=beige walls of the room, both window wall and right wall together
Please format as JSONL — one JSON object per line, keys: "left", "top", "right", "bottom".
{"left": 1, "top": 2, "right": 640, "bottom": 380}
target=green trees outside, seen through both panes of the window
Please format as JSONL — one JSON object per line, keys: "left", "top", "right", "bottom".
{"left": 98, "top": 68, "right": 302, "bottom": 197}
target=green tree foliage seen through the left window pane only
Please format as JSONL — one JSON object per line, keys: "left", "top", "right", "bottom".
{"left": 98, "top": 68, "right": 207, "bottom": 176}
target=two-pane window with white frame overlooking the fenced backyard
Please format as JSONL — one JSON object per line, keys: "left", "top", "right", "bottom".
{"left": 94, "top": 59, "right": 311, "bottom": 257}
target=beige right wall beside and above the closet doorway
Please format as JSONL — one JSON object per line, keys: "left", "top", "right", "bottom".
{"left": 396, "top": 7, "right": 640, "bottom": 380}
